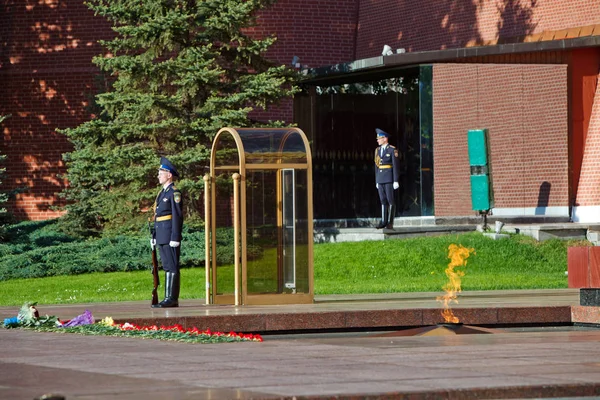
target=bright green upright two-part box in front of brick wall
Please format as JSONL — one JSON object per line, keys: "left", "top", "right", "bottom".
{"left": 467, "top": 129, "right": 494, "bottom": 211}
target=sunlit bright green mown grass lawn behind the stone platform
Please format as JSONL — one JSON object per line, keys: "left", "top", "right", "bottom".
{"left": 0, "top": 232, "right": 590, "bottom": 306}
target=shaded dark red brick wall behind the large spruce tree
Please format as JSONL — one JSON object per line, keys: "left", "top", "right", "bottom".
{"left": 0, "top": 0, "right": 358, "bottom": 220}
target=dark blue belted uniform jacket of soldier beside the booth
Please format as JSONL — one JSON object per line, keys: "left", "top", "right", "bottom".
{"left": 154, "top": 184, "right": 183, "bottom": 244}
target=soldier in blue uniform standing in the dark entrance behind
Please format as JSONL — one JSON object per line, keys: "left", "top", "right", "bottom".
{"left": 375, "top": 128, "right": 400, "bottom": 229}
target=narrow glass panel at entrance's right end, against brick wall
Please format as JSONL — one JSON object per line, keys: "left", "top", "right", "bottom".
{"left": 419, "top": 65, "right": 434, "bottom": 215}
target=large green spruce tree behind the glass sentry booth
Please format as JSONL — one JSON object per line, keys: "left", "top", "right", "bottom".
{"left": 61, "top": 0, "right": 297, "bottom": 236}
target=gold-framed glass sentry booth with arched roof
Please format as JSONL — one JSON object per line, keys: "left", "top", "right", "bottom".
{"left": 204, "top": 128, "right": 314, "bottom": 305}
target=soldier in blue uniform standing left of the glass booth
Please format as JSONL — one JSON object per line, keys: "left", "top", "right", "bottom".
{"left": 151, "top": 157, "right": 183, "bottom": 308}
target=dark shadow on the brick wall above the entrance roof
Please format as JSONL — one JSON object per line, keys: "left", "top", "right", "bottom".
{"left": 357, "top": 0, "right": 538, "bottom": 59}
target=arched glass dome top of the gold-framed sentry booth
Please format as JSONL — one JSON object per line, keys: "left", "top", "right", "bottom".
{"left": 212, "top": 128, "right": 310, "bottom": 167}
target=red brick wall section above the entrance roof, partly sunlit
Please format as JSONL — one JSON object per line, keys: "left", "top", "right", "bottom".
{"left": 356, "top": 0, "right": 600, "bottom": 59}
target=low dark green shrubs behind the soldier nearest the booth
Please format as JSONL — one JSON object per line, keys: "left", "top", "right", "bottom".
{"left": 0, "top": 220, "right": 260, "bottom": 281}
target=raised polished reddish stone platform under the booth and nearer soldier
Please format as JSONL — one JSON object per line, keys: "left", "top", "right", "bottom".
{"left": 0, "top": 289, "right": 579, "bottom": 333}
